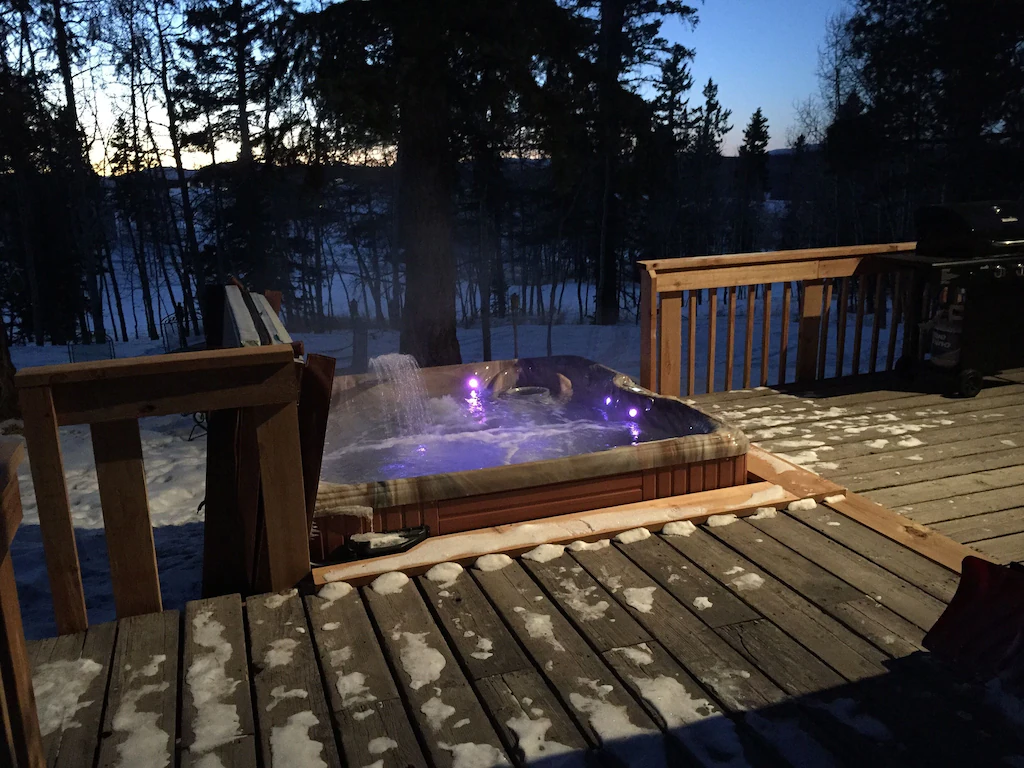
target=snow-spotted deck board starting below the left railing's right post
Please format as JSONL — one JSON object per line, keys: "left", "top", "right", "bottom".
{"left": 246, "top": 590, "right": 341, "bottom": 768}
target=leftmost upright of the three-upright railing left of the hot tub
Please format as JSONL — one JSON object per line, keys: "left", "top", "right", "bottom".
{"left": 19, "top": 387, "right": 89, "bottom": 635}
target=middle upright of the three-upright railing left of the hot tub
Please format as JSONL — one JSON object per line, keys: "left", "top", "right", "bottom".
{"left": 90, "top": 419, "right": 163, "bottom": 618}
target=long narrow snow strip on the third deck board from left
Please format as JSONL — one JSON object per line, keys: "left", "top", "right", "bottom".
{"left": 185, "top": 614, "right": 241, "bottom": 755}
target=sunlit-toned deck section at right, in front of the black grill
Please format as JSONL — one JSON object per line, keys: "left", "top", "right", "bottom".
{"left": 694, "top": 370, "right": 1024, "bottom": 562}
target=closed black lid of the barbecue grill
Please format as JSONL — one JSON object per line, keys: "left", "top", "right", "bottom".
{"left": 915, "top": 201, "right": 1024, "bottom": 259}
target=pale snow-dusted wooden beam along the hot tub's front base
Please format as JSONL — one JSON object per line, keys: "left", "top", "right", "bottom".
{"left": 313, "top": 482, "right": 798, "bottom": 586}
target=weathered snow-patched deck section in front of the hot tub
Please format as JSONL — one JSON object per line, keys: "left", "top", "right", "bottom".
{"left": 24, "top": 495, "right": 1024, "bottom": 768}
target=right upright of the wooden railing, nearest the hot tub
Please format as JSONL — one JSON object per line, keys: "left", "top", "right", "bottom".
{"left": 254, "top": 402, "right": 309, "bottom": 592}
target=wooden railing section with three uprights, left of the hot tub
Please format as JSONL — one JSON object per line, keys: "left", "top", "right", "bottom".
{"left": 14, "top": 345, "right": 309, "bottom": 635}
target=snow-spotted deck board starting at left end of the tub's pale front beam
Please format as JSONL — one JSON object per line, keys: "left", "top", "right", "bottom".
{"left": 306, "top": 587, "right": 427, "bottom": 768}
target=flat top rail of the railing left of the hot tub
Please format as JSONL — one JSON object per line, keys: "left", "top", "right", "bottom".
{"left": 14, "top": 344, "right": 294, "bottom": 388}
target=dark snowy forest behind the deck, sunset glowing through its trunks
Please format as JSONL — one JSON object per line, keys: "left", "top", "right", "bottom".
{"left": 0, "top": 0, "right": 1024, "bottom": 369}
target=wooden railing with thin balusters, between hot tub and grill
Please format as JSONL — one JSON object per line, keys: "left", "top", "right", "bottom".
{"left": 640, "top": 243, "right": 915, "bottom": 395}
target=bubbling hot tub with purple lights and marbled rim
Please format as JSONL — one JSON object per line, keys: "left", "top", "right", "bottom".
{"left": 313, "top": 356, "right": 748, "bottom": 557}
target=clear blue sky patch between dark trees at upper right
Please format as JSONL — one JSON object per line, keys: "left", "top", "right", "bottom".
{"left": 663, "top": 0, "right": 847, "bottom": 155}
